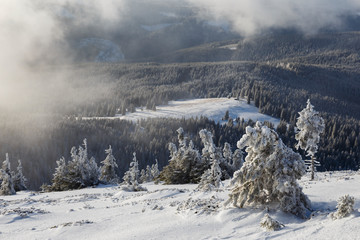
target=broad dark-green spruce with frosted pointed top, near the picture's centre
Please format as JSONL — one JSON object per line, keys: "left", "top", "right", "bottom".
{"left": 159, "top": 128, "right": 208, "bottom": 184}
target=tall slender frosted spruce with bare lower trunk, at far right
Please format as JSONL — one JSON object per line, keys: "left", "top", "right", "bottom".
{"left": 295, "top": 99, "right": 325, "bottom": 180}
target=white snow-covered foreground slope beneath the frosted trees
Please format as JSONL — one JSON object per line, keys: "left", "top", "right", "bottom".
{"left": 0, "top": 172, "right": 360, "bottom": 240}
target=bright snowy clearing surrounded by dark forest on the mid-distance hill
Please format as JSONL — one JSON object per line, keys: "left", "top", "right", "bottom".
{"left": 112, "top": 98, "right": 280, "bottom": 126}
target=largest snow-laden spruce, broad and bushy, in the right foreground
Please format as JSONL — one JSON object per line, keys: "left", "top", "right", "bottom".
{"left": 226, "top": 122, "right": 310, "bottom": 218}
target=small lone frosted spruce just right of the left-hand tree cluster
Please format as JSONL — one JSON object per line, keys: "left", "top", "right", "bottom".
{"left": 100, "top": 146, "right": 119, "bottom": 184}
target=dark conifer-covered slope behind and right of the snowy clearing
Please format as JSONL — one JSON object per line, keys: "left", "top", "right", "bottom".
{"left": 65, "top": 62, "right": 360, "bottom": 170}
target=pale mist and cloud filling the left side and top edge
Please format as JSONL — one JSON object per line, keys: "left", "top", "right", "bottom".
{"left": 0, "top": 0, "right": 360, "bottom": 118}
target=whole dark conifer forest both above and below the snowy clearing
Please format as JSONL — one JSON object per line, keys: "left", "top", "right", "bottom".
{"left": 0, "top": 34, "right": 360, "bottom": 189}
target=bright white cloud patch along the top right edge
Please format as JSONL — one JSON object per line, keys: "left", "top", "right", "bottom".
{"left": 187, "top": 0, "right": 360, "bottom": 37}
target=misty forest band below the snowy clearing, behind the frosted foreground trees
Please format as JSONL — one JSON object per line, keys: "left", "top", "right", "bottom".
{"left": 0, "top": 117, "right": 253, "bottom": 189}
